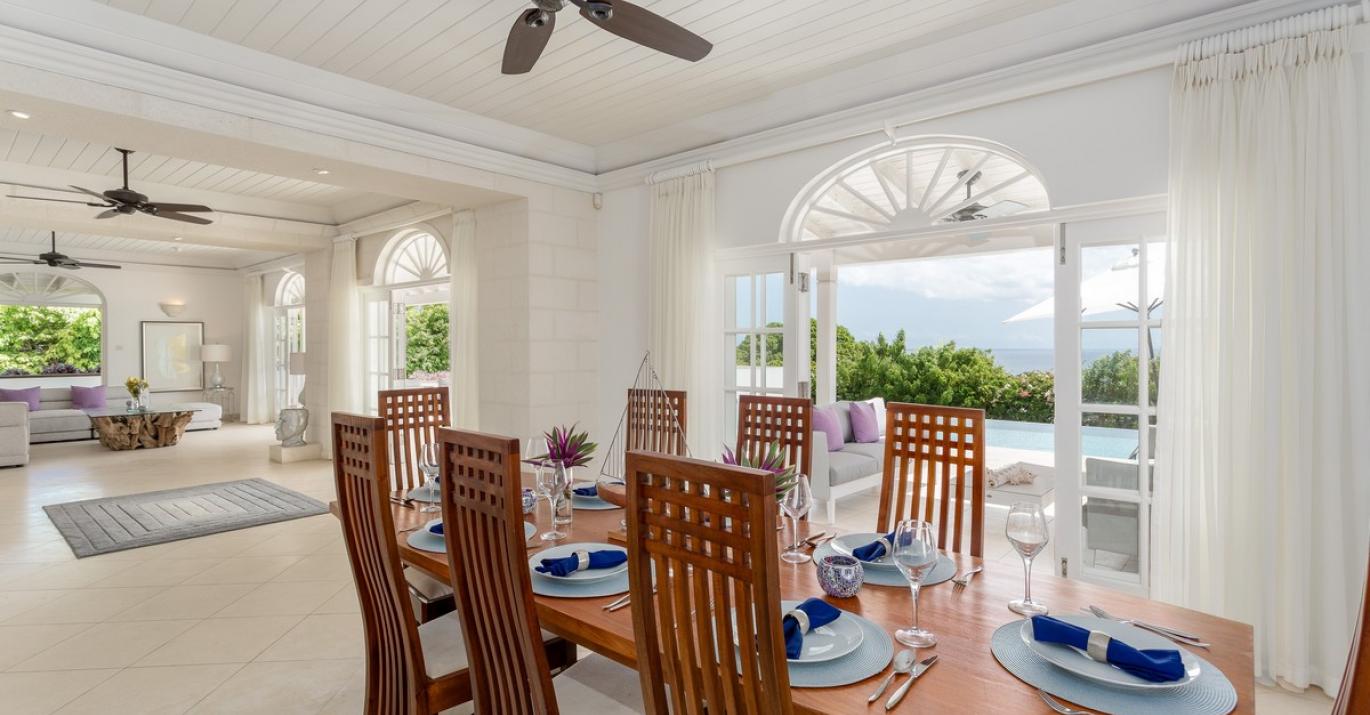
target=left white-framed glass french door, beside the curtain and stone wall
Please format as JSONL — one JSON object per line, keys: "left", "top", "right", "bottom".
{"left": 719, "top": 255, "right": 810, "bottom": 444}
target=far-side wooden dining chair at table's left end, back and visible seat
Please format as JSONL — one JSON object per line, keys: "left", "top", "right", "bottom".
{"left": 377, "top": 388, "right": 455, "bottom": 623}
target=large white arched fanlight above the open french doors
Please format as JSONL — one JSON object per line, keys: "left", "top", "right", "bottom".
{"left": 785, "top": 137, "right": 1049, "bottom": 241}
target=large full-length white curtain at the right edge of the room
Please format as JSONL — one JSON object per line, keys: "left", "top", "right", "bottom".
{"left": 1152, "top": 8, "right": 1370, "bottom": 693}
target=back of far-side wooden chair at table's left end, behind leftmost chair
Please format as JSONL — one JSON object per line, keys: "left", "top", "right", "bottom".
{"left": 377, "top": 388, "right": 451, "bottom": 489}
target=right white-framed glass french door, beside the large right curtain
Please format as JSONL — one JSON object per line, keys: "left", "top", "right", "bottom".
{"left": 1055, "top": 215, "right": 1166, "bottom": 594}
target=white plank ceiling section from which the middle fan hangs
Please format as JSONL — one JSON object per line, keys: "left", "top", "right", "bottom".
{"left": 0, "top": 127, "right": 366, "bottom": 207}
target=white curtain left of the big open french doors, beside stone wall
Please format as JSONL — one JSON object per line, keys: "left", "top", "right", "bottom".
{"left": 648, "top": 168, "right": 723, "bottom": 456}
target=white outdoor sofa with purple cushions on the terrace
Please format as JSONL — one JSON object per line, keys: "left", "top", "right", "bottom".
{"left": 808, "top": 397, "right": 885, "bottom": 523}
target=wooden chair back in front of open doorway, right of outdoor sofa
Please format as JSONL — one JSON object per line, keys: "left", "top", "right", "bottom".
{"left": 875, "top": 403, "right": 985, "bottom": 556}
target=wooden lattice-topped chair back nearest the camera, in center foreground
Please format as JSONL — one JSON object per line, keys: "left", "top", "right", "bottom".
{"left": 626, "top": 451, "right": 793, "bottom": 715}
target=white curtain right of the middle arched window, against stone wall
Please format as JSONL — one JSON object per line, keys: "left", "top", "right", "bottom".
{"left": 449, "top": 211, "right": 481, "bottom": 430}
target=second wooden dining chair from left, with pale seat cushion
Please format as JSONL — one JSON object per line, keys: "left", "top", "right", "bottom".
{"left": 438, "top": 427, "right": 641, "bottom": 715}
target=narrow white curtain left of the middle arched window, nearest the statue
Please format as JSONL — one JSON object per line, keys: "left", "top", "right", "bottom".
{"left": 324, "top": 238, "right": 366, "bottom": 416}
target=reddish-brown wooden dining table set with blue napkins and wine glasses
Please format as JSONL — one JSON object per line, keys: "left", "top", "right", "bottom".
{"left": 353, "top": 490, "right": 1255, "bottom": 715}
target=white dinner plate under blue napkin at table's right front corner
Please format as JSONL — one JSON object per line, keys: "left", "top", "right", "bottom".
{"left": 1021, "top": 615, "right": 1199, "bottom": 690}
